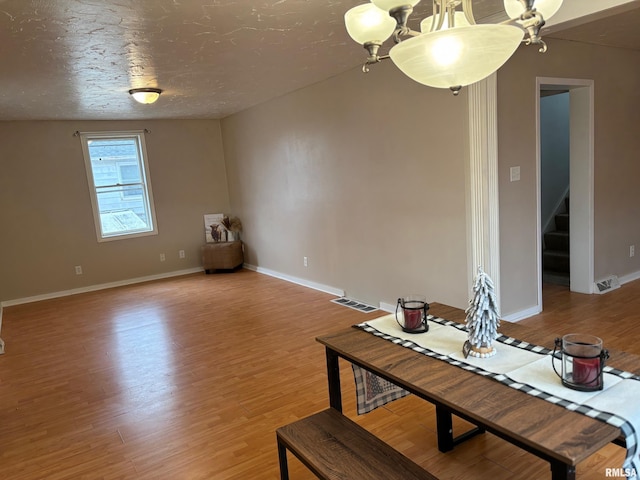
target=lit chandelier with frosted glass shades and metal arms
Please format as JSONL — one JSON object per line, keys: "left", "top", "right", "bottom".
{"left": 344, "top": 0, "right": 562, "bottom": 95}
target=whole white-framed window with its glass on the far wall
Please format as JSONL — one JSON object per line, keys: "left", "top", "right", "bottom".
{"left": 80, "top": 132, "right": 158, "bottom": 242}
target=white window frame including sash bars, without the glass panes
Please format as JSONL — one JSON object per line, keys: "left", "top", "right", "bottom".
{"left": 80, "top": 130, "right": 158, "bottom": 242}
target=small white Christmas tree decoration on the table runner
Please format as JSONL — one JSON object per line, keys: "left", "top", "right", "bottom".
{"left": 464, "top": 267, "right": 500, "bottom": 358}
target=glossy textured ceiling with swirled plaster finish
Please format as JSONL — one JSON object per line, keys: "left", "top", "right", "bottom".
{"left": 0, "top": 0, "right": 640, "bottom": 120}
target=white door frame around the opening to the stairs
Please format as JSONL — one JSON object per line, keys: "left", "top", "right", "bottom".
{"left": 536, "top": 77, "right": 594, "bottom": 310}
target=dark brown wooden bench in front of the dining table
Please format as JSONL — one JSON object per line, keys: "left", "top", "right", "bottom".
{"left": 276, "top": 408, "right": 437, "bottom": 480}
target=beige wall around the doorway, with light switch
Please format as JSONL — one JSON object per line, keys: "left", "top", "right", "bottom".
{"left": 498, "top": 39, "right": 640, "bottom": 315}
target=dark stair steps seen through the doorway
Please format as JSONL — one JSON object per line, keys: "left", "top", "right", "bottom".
{"left": 542, "top": 197, "right": 570, "bottom": 286}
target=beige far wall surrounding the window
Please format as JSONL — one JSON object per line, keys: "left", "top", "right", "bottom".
{"left": 0, "top": 120, "right": 229, "bottom": 301}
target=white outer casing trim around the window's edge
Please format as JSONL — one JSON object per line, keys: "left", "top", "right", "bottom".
{"left": 78, "top": 130, "right": 158, "bottom": 243}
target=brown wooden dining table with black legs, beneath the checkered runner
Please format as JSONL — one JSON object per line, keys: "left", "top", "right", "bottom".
{"left": 316, "top": 303, "right": 640, "bottom": 480}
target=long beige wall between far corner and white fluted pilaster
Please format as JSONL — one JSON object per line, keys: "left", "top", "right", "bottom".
{"left": 222, "top": 62, "right": 469, "bottom": 307}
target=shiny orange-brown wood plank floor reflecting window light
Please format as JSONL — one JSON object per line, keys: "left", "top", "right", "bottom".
{"left": 0, "top": 270, "right": 640, "bottom": 480}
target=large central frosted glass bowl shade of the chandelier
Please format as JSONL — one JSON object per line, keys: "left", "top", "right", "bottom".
{"left": 389, "top": 25, "right": 523, "bottom": 89}
